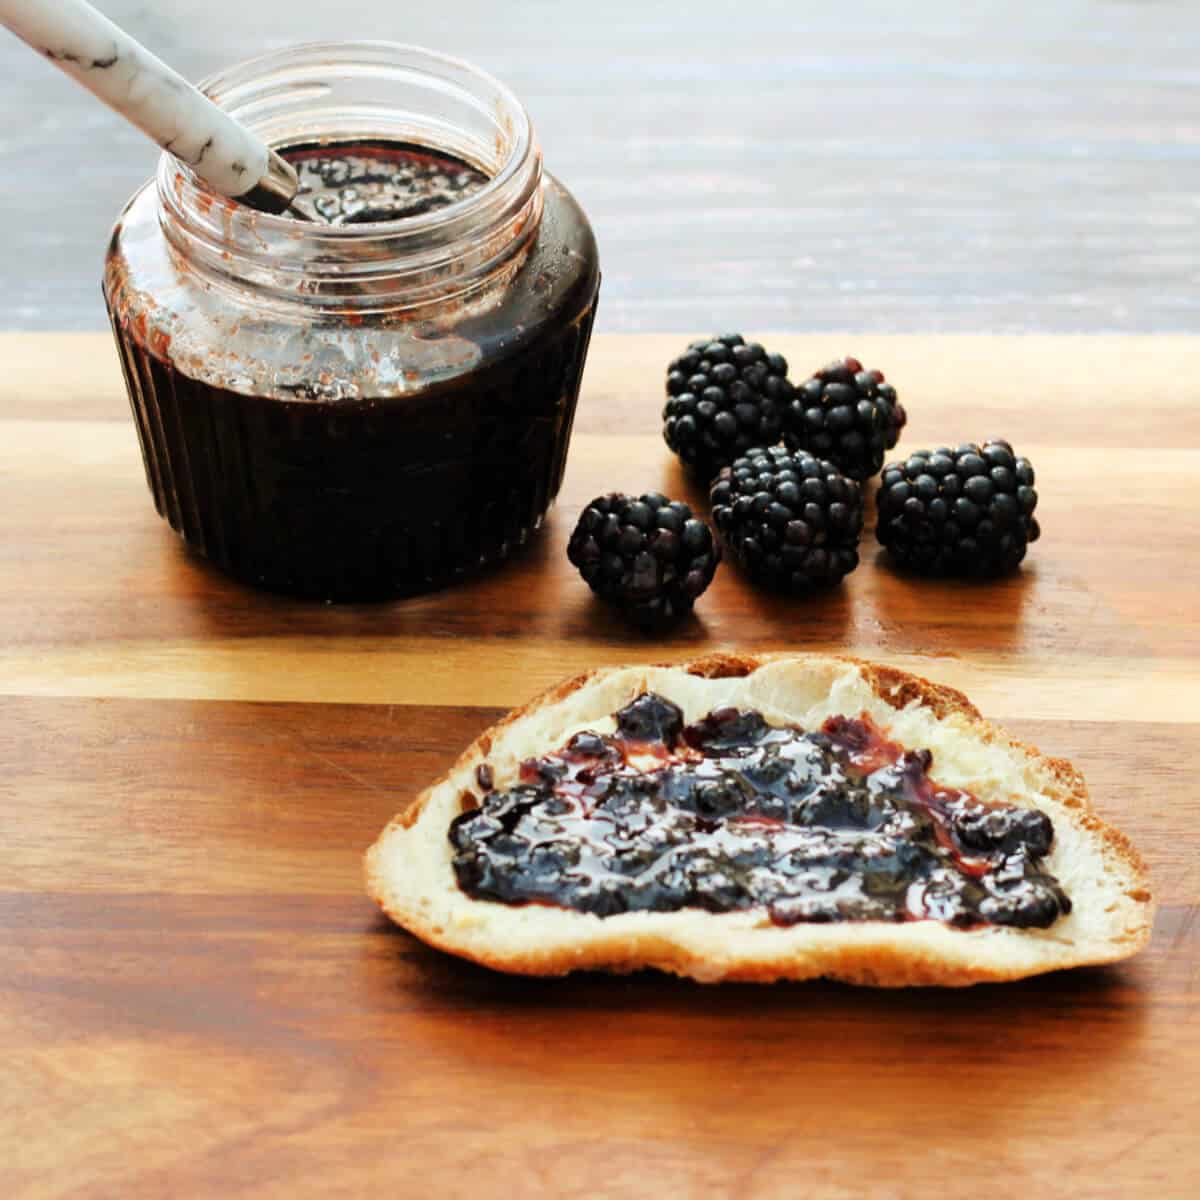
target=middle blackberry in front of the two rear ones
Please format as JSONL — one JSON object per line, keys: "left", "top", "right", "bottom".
{"left": 712, "top": 446, "right": 863, "bottom": 594}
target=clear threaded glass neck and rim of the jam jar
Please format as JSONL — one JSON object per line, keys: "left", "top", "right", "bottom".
{"left": 157, "top": 41, "right": 542, "bottom": 310}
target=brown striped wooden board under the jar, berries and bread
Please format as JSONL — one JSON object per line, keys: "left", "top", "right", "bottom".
{"left": 0, "top": 335, "right": 1200, "bottom": 1200}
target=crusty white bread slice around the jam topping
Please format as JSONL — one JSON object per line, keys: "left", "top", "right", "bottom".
{"left": 366, "top": 655, "right": 1154, "bottom": 986}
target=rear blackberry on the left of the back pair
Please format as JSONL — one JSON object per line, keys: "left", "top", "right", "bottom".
{"left": 662, "top": 334, "right": 794, "bottom": 484}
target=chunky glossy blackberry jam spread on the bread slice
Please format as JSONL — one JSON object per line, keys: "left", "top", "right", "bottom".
{"left": 450, "top": 694, "right": 1070, "bottom": 929}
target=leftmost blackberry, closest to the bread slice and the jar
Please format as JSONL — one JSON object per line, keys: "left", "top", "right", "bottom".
{"left": 566, "top": 492, "right": 721, "bottom": 628}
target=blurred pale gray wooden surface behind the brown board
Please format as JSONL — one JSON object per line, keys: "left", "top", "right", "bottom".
{"left": 0, "top": 0, "right": 1200, "bottom": 331}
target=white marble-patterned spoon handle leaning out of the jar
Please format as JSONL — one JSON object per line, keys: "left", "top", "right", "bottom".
{"left": 0, "top": 0, "right": 296, "bottom": 212}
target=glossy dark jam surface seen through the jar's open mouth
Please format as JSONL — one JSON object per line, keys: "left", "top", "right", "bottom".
{"left": 281, "top": 142, "right": 487, "bottom": 226}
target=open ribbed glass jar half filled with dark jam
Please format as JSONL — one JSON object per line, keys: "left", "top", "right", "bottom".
{"left": 103, "top": 42, "right": 600, "bottom": 600}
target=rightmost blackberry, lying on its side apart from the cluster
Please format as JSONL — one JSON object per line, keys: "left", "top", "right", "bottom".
{"left": 875, "top": 440, "right": 1042, "bottom": 578}
